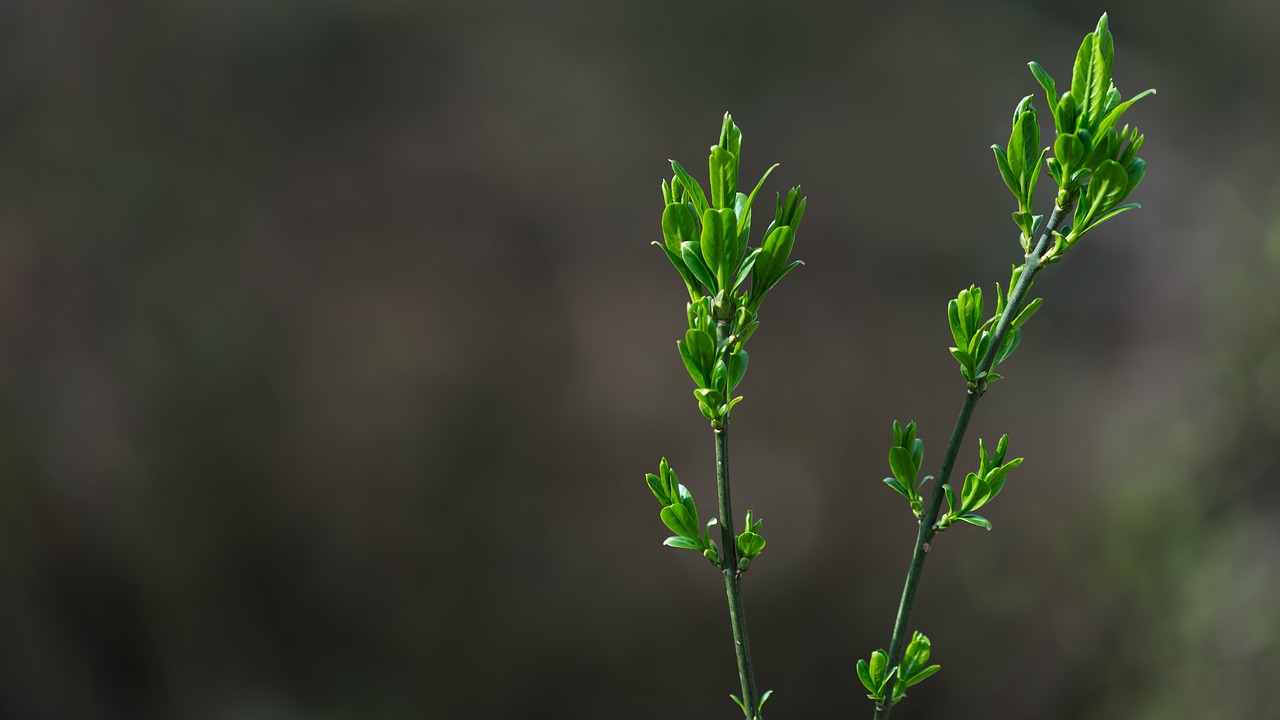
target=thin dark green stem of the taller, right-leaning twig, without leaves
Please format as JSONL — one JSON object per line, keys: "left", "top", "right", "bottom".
{"left": 876, "top": 202, "right": 1070, "bottom": 720}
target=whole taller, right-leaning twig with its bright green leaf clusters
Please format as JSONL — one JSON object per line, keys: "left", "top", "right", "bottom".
{"left": 858, "top": 15, "right": 1155, "bottom": 720}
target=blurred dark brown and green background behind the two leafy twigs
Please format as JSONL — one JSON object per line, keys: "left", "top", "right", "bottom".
{"left": 0, "top": 0, "right": 1280, "bottom": 720}
